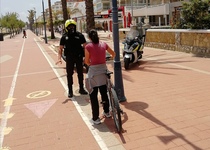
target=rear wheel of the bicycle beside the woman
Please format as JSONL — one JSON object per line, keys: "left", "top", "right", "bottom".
{"left": 110, "top": 88, "right": 122, "bottom": 132}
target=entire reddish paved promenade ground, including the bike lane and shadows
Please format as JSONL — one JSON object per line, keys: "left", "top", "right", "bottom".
{"left": 0, "top": 30, "right": 210, "bottom": 150}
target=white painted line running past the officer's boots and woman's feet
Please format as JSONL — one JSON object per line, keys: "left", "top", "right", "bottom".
{"left": 35, "top": 38, "right": 108, "bottom": 150}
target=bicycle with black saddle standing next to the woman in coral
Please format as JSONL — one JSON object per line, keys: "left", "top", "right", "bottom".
{"left": 106, "top": 70, "right": 123, "bottom": 132}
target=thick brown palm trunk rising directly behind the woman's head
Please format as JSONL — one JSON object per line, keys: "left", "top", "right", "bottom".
{"left": 85, "top": 0, "right": 95, "bottom": 32}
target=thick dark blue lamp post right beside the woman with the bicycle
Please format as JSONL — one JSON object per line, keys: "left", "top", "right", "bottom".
{"left": 112, "top": 0, "right": 126, "bottom": 102}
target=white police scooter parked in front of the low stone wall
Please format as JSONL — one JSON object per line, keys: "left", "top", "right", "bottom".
{"left": 123, "top": 23, "right": 146, "bottom": 70}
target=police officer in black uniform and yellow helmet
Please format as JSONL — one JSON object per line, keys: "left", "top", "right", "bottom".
{"left": 56, "top": 19, "right": 88, "bottom": 98}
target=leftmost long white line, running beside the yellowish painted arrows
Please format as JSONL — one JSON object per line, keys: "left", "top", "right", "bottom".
{"left": 0, "top": 39, "right": 25, "bottom": 149}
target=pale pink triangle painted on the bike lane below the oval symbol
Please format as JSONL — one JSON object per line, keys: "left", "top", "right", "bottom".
{"left": 24, "top": 99, "right": 57, "bottom": 119}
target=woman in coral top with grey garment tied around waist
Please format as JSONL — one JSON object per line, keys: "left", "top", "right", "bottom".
{"left": 85, "top": 29, "right": 115, "bottom": 124}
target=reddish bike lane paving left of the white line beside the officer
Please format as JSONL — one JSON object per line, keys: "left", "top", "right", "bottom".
{"left": 1, "top": 31, "right": 99, "bottom": 150}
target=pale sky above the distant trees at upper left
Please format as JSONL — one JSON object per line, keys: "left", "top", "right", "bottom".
{"left": 0, "top": 0, "right": 57, "bottom": 22}
